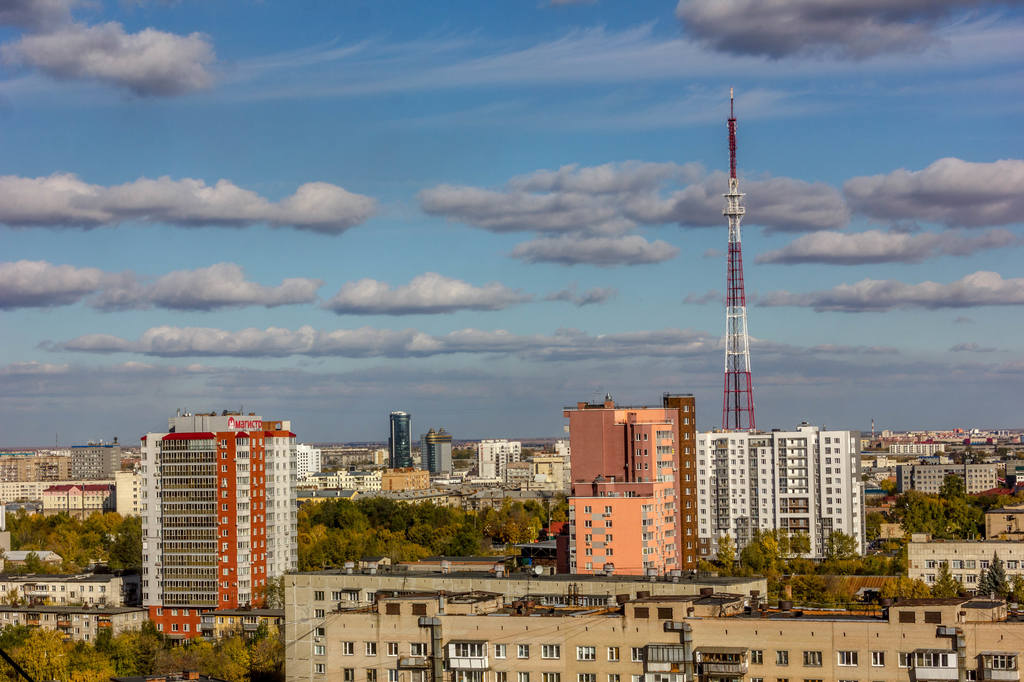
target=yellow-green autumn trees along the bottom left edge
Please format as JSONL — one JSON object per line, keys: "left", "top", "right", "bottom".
{"left": 0, "top": 622, "right": 285, "bottom": 682}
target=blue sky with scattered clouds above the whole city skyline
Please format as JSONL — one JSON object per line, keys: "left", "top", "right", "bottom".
{"left": 0, "top": 0, "right": 1024, "bottom": 445}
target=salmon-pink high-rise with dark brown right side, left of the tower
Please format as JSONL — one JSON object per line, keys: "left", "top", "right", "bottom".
{"left": 563, "top": 394, "right": 697, "bottom": 574}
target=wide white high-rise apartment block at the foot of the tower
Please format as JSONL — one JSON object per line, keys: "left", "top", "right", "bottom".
{"left": 696, "top": 424, "right": 864, "bottom": 558}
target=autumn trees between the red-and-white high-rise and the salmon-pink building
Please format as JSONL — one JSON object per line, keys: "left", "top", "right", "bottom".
{"left": 298, "top": 498, "right": 567, "bottom": 570}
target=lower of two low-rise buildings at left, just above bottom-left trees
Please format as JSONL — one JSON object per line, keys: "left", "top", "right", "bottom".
{"left": 0, "top": 605, "right": 148, "bottom": 642}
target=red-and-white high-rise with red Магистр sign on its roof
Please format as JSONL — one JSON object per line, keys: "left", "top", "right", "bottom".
{"left": 141, "top": 414, "right": 297, "bottom": 638}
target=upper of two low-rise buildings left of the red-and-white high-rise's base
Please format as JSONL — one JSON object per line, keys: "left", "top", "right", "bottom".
{"left": 0, "top": 571, "right": 141, "bottom": 606}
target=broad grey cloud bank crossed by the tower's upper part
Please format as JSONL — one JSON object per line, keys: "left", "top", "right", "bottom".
{"left": 419, "top": 161, "right": 850, "bottom": 254}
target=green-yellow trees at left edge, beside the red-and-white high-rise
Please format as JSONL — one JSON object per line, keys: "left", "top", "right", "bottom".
{"left": 4, "top": 511, "right": 142, "bottom": 573}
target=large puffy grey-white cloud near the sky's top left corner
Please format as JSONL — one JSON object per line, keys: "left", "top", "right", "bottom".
{"left": 0, "top": 22, "right": 215, "bottom": 95}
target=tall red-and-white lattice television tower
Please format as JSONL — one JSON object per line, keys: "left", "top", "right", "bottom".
{"left": 722, "top": 88, "right": 756, "bottom": 430}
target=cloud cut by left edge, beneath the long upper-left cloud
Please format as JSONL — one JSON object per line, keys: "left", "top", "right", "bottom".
{"left": 0, "top": 260, "right": 109, "bottom": 310}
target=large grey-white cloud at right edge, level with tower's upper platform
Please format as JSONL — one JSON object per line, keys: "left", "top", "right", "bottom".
{"left": 843, "top": 158, "right": 1024, "bottom": 227}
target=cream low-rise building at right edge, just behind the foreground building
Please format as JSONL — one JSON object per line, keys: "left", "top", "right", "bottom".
{"left": 906, "top": 535, "right": 1024, "bottom": 591}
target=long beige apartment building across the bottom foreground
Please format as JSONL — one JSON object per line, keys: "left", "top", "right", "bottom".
{"left": 286, "top": 592, "right": 1024, "bottom": 682}
